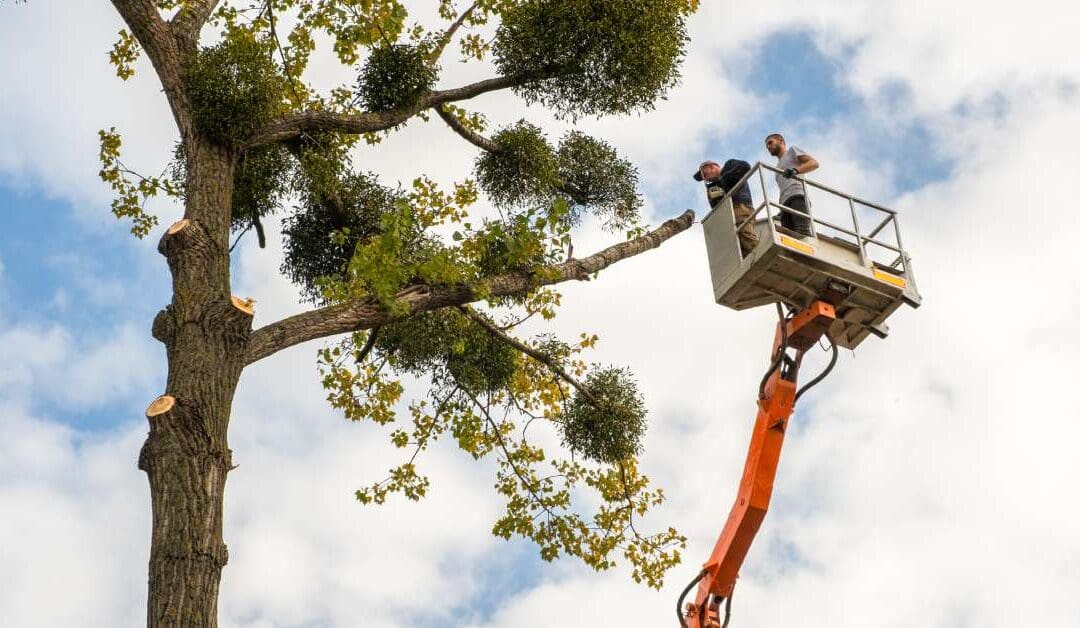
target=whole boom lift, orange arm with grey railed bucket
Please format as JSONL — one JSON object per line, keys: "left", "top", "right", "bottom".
{"left": 676, "top": 163, "right": 921, "bottom": 628}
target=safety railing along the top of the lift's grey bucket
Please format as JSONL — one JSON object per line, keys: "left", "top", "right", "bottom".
{"left": 706, "top": 162, "right": 912, "bottom": 276}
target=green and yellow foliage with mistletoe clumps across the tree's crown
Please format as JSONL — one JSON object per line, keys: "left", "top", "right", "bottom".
{"left": 102, "top": 0, "right": 698, "bottom": 587}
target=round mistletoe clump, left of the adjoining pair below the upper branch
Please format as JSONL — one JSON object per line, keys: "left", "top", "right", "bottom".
{"left": 475, "top": 120, "right": 559, "bottom": 205}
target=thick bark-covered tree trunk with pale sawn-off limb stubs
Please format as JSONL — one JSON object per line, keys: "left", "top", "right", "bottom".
{"left": 138, "top": 138, "right": 244, "bottom": 628}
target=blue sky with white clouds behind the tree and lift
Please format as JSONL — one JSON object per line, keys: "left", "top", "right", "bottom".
{"left": 0, "top": 0, "right": 1080, "bottom": 628}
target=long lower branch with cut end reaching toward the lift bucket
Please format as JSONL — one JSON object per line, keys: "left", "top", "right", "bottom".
{"left": 246, "top": 210, "right": 693, "bottom": 364}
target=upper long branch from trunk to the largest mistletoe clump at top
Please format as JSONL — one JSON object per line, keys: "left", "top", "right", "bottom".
{"left": 244, "top": 76, "right": 530, "bottom": 149}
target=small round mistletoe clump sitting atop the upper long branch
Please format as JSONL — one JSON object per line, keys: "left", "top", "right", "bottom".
{"left": 356, "top": 43, "right": 438, "bottom": 111}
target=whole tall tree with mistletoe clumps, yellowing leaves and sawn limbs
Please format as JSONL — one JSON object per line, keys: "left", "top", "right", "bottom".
{"left": 86, "top": 0, "right": 698, "bottom": 626}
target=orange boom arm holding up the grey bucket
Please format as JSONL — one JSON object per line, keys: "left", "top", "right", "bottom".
{"left": 679, "top": 300, "right": 836, "bottom": 628}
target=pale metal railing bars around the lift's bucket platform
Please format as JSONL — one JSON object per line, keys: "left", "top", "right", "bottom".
{"left": 705, "top": 162, "right": 912, "bottom": 276}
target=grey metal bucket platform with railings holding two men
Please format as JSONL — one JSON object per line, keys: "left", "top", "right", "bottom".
{"left": 702, "top": 163, "right": 921, "bottom": 349}
